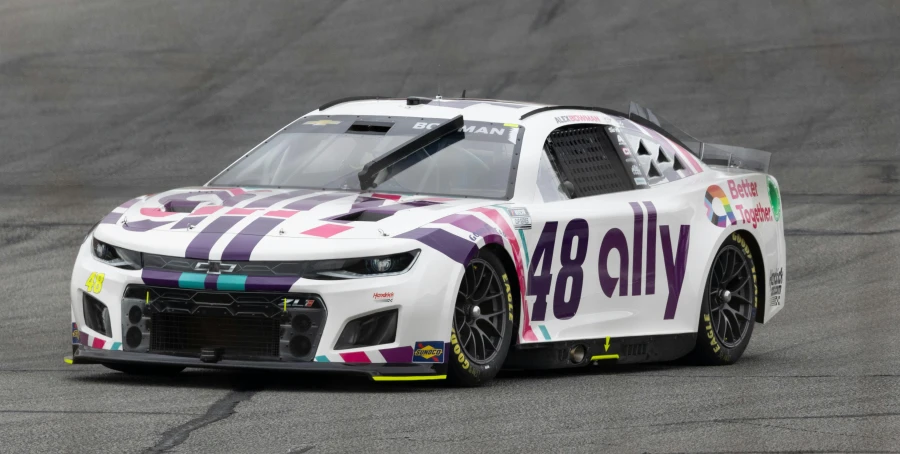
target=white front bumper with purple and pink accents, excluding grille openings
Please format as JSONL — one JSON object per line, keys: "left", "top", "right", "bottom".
{"left": 70, "top": 234, "right": 462, "bottom": 380}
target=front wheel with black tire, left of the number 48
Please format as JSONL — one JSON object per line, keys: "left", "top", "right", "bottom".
{"left": 447, "top": 250, "right": 515, "bottom": 386}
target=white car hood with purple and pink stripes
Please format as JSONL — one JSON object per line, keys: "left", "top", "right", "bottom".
{"left": 95, "top": 187, "right": 510, "bottom": 259}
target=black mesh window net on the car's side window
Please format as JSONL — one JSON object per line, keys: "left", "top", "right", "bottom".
{"left": 547, "top": 125, "right": 634, "bottom": 197}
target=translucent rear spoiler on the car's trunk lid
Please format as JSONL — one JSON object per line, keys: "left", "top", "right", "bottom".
{"left": 628, "top": 102, "right": 772, "bottom": 173}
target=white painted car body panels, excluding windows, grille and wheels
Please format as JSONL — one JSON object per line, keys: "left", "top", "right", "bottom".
{"left": 70, "top": 99, "right": 786, "bottom": 378}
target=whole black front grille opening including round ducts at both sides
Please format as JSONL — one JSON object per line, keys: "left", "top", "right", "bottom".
{"left": 121, "top": 284, "right": 327, "bottom": 362}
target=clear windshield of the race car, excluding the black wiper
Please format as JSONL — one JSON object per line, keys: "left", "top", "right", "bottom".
{"left": 210, "top": 116, "right": 523, "bottom": 199}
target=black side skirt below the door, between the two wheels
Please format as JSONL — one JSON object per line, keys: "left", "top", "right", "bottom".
{"left": 503, "top": 333, "right": 697, "bottom": 369}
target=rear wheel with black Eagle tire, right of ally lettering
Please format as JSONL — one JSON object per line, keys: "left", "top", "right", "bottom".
{"left": 692, "top": 233, "right": 759, "bottom": 366}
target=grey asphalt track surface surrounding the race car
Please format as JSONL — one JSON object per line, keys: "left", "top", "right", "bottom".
{"left": 0, "top": 0, "right": 900, "bottom": 453}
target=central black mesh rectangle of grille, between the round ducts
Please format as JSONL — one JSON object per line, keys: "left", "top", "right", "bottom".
{"left": 150, "top": 313, "right": 281, "bottom": 357}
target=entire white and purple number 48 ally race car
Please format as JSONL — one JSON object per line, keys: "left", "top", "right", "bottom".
{"left": 66, "top": 97, "right": 785, "bottom": 385}
